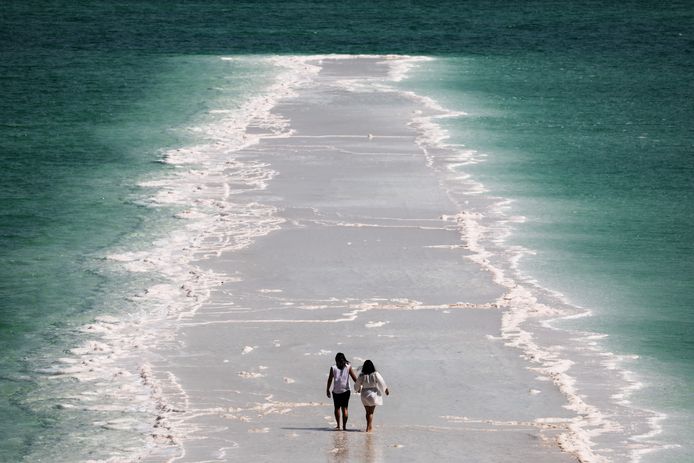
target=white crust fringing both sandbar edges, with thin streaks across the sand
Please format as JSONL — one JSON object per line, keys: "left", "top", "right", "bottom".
{"left": 50, "top": 55, "right": 666, "bottom": 463}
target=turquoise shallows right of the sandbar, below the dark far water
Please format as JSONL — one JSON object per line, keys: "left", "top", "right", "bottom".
{"left": 406, "top": 49, "right": 694, "bottom": 461}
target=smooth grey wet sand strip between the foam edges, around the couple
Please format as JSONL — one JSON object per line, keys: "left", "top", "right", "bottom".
{"left": 141, "top": 57, "right": 576, "bottom": 462}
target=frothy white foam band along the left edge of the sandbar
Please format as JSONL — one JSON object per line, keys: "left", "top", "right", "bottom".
{"left": 46, "top": 53, "right": 334, "bottom": 460}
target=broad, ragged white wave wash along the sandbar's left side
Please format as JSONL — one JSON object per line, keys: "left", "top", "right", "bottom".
{"left": 24, "top": 57, "right": 318, "bottom": 462}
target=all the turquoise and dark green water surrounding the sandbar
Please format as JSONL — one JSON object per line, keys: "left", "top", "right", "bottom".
{"left": 0, "top": 0, "right": 694, "bottom": 461}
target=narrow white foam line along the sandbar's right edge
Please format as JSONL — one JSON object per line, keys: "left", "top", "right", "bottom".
{"left": 364, "top": 55, "right": 676, "bottom": 463}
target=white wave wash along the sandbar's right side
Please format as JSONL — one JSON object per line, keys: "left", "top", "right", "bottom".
{"left": 402, "top": 58, "right": 672, "bottom": 463}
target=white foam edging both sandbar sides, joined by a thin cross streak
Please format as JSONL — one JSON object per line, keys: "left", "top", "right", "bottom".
{"left": 56, "top": 55, "right": 668, "bottom": 463}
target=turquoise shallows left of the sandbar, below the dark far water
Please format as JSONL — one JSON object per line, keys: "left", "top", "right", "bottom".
{"left": 0, "top": 44, "right": 280, "bottom": 461}
